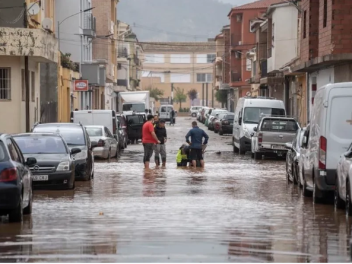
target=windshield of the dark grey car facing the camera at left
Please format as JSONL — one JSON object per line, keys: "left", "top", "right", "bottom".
{"left": 14, "top": 136, "right": 67, "bottom": 154}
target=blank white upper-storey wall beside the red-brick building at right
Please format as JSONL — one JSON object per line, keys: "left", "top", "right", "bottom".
{"left": 268, "top": 5, "right": 298, "bottom": 71}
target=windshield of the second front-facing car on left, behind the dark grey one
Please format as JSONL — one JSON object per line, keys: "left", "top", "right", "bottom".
{"left": 34, "top": 126, "right": 86, "bottom": 146}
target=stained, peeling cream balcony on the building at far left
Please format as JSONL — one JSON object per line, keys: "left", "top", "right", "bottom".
{"left": 0, "top": 27, "right": 59, "bottom": 63}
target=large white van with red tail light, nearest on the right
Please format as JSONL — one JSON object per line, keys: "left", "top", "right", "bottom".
{"left": 302, "top": 82, "right": 352, "bottom": 202}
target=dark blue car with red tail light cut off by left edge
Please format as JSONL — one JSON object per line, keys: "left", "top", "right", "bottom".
{"left": 0, "top": 134, "right": 37, "bottom": 222}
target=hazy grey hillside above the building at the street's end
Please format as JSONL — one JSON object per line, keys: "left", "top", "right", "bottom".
{"left": 118, "top": 0, "right": 231, "bottom": 41}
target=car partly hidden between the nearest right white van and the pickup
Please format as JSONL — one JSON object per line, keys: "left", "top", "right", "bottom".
{"left": 286, "top": 128, "right": 306, "bottom": 186}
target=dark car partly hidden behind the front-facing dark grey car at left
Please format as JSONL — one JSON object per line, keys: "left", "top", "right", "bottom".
{"left": 32, "top": 123, "right": 94, "bottom": 181}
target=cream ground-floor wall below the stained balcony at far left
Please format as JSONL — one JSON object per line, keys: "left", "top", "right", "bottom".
{"left": 0, "top": 56, "right": 40, "bottom": 134}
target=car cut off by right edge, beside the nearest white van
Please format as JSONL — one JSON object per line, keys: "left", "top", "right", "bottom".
{"left": 334, "top": 144, "right": 352, "bottom": 216}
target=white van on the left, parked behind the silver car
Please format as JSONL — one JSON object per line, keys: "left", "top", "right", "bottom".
{"left": 71, "top": 110, "right": 118, "bottom": 138}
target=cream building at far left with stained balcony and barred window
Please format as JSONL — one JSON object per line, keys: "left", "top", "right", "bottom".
{"left": 0, "top": 0, "right": 59, "bottom": 133}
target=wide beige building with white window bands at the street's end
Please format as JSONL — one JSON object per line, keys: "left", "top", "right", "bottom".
{"left": 141, "top": 39, "right": 218, "bottom": 109}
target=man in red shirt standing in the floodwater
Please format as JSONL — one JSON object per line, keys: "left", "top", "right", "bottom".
{"left": 142, "top": 115, "right": 160, "bottom": 169}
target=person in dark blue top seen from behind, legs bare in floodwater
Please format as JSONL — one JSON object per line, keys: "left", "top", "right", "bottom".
{"left": 186, "top": 121, "right": 209, "bottom": 168}
